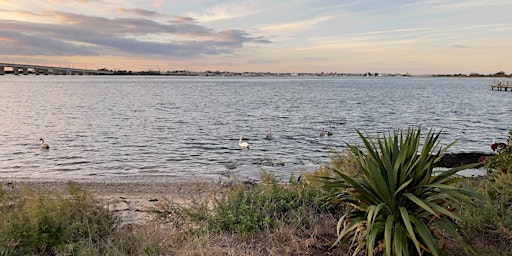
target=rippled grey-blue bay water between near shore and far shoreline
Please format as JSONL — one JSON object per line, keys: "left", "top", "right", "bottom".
{"left": 0, "top": 75, "right": 512, "bottom": 181}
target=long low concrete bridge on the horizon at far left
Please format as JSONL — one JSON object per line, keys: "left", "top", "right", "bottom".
{"left": 0, "top": 63, "right": 113, "bottom": 75}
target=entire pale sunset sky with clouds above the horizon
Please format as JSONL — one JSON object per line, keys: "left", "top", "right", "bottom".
{"left": 0, "top": 0, "right": 512, "bottom": 74}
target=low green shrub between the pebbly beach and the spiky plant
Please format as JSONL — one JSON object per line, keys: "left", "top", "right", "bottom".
{"left": 187, "top": 171, "right": 328, "bottom": 234}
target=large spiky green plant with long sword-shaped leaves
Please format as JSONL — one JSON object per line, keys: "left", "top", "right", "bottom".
{"left": 324, "top": 128, "right": 478, "bottom": 255}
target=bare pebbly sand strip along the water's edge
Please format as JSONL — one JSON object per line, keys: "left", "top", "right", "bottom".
{"left": 0, "top": 180, "right": 227, "bottom": 225}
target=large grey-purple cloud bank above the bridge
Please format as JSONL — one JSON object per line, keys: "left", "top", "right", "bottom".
{"left": 0, "top": 9, "right": 269, "bottom": 58}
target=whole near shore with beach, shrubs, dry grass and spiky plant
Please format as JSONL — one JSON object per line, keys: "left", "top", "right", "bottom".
{"left": 0, "top": 128, "right": 512, "bottom": 255}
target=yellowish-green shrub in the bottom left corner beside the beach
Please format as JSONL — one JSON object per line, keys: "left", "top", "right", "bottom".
{"left": 0, "top": 183, "right": 115, "bottom": 255}
